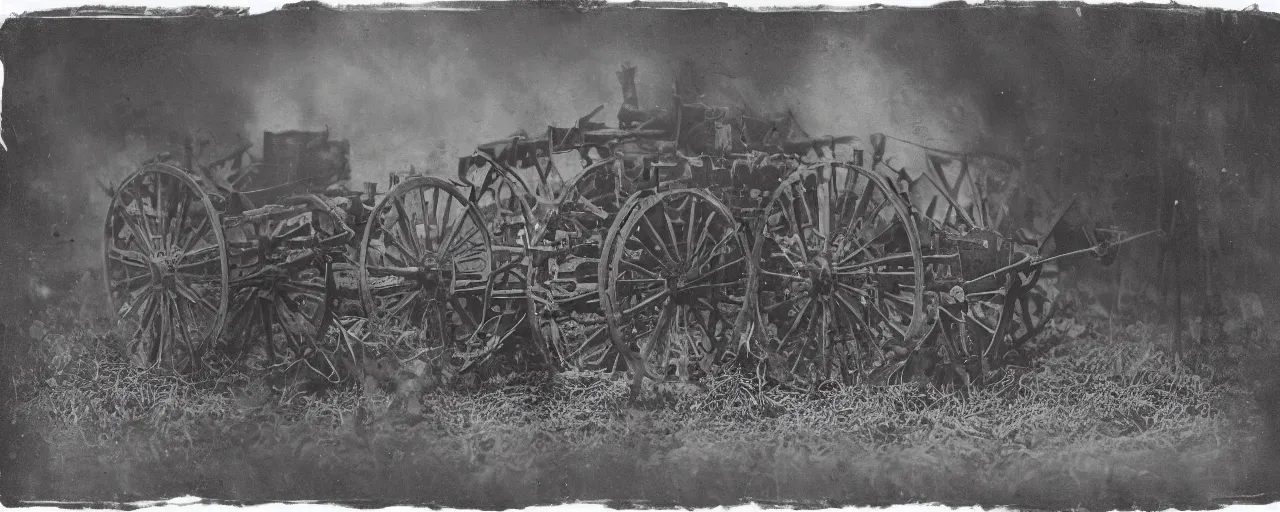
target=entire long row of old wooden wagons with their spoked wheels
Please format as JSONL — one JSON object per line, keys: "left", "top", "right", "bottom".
{"left": 105, "top": 62, "right": 1162, "bottom": 385}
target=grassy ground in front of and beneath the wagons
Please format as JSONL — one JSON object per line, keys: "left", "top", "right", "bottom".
{"left": 0, "top": 270, "right": 1274, "bottom": 509}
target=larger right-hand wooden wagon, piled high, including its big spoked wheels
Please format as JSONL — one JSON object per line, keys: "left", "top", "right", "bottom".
{"left": 445, "top": 67, "right": 1157, "bottom": 389}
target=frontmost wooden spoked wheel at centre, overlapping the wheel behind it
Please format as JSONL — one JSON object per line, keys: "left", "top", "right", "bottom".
{"left": 599, "top": 189, "right": 750, "bottom": 384}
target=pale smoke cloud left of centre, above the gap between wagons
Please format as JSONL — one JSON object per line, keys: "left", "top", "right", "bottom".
{"left": 242, "top": 22, "right": 670, "bottom": 183}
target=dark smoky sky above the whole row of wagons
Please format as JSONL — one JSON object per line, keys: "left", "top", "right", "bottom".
{"left": 0, "top": 5, "right": 1280, "bottom": 299}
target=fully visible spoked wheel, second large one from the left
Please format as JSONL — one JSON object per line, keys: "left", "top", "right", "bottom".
{"left": 360, "top": 177, "right": 513, "bottom": 372}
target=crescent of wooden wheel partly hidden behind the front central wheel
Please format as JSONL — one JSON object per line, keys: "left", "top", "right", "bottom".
{"left": 529, "top": 160, "right": 637, "bottom": 370}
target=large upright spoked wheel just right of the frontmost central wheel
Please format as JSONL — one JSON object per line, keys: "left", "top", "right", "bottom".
{"left": 753, "top": 164, "right": 925, "bottom": 385}
